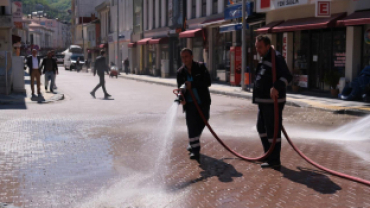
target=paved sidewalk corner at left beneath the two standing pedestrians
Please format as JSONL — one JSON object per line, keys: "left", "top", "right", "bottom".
{"left": 0, "top": 74, "right": 64, "bottom": 105}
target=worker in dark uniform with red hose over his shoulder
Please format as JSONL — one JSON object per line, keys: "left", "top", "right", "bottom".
{"left": 253, "top": 36, "right": 293, "bottom": 169}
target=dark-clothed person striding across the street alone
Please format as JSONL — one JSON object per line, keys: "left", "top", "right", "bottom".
{"left": 90, "top": 50, "right": 111, "bottom": 99}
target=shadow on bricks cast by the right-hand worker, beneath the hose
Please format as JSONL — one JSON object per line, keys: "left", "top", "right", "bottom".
{"left": 280, "top": 166, "right": 342, "bottom": 194}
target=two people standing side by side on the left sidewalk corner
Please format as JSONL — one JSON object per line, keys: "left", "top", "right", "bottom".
{"left": 26, "top": 49, "right": 59, "bottom": 97}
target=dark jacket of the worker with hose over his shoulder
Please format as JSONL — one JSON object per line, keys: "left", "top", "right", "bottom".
{"left": 253, "top": 50, "right": 293, "bottom": 104}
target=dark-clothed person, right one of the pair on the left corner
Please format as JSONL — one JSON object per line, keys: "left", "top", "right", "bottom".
{"left": 40, "top": 51, "right": 58, "bottom": 93}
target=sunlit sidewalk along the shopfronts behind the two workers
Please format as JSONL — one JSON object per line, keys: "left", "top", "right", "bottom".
{"left": 119, "top": 73, "right": 370, "bottom": 114}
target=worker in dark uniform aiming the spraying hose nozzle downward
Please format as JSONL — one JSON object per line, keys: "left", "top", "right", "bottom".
{"left": 177, "top": 48, "right": 211, "bottom": 161}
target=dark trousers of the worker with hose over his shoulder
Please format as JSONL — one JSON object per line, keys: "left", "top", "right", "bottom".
{"left": 257, "top": 103, "right": 285, "bottom": 164}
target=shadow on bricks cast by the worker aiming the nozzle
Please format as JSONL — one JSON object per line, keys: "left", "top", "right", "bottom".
{"left": 171, "top": 154, "right": 243, "bottom": 189}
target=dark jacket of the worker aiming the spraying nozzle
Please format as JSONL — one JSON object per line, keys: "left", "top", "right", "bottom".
{"left": 177, "top": 61, "right": 211, "bottom": 110}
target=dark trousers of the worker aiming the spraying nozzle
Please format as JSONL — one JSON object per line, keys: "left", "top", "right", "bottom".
{"left": 185, "top": 102, "right": 210, "bottom": 153}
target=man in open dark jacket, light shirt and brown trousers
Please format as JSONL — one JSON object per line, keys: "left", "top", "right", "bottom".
{"left": 27, "top": 49, "right": 41, "bottom": 97}
